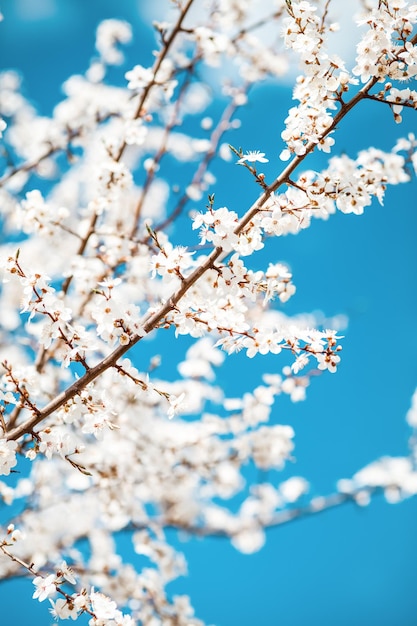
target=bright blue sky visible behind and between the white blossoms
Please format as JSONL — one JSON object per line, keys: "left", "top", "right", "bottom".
{"left": 0, "top": 0, "right": 417, "bottom": 626}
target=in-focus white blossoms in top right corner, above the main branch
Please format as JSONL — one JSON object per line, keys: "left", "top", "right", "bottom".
{"left": 281, "top": 0, "right": 417, "bottom": 160}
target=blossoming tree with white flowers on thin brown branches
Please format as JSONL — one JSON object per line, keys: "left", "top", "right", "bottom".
{"left": 0, "top": 0, "right": 417, "bottom": 626}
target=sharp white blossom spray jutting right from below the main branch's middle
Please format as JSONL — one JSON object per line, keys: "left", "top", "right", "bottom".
{"left": 161, "top": 254, "right": 341, "bottom": 372}
